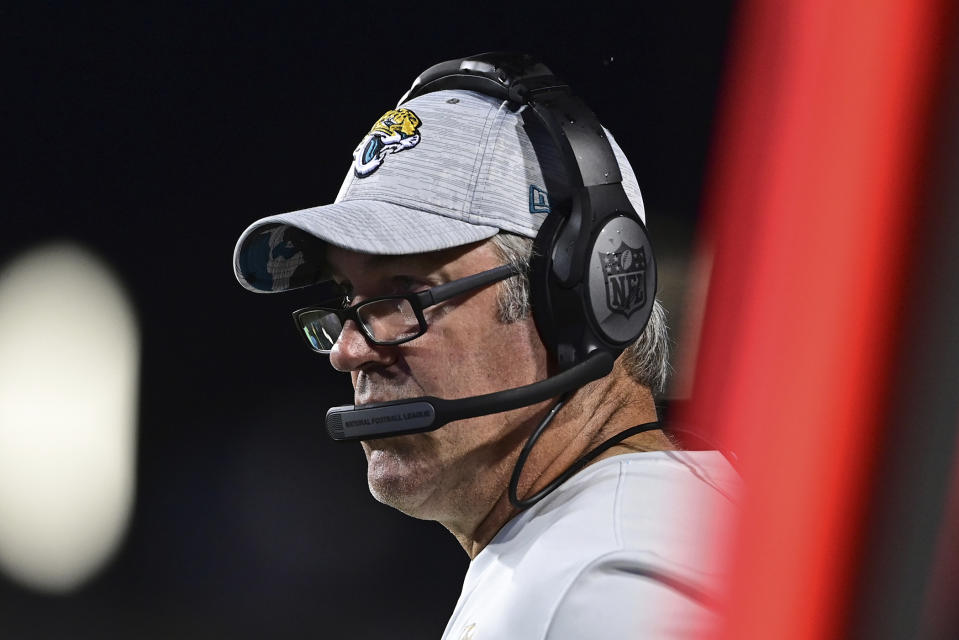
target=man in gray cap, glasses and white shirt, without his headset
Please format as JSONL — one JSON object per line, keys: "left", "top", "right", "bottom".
{"left": 234, "top": 57, "right": 737, "bottom": 640}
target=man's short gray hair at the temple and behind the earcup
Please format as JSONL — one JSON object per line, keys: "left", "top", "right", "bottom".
{"left": 491, "top": 231, "right": 669, "bottom": 392}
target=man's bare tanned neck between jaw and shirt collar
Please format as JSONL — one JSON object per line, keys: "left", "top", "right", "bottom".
{"left": 448, "top": 364, "right": 675, "bottom": 559}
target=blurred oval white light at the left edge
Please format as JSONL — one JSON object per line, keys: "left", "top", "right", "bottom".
{"left": 0, "top": 244, "right": 139, "bottom": 592}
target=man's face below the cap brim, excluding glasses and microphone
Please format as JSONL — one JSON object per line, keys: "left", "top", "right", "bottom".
{"left": 327, "top": 242, "right": 546, "bottom": 524}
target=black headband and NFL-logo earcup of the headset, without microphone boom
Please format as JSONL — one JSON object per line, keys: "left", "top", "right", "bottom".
{"left": 400, "top": 52, "right": 656, "bottom": 371}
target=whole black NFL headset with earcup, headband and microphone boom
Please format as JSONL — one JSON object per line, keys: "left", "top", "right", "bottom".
{"left": 326, "top": 52, "right": 658, "bottom": 450}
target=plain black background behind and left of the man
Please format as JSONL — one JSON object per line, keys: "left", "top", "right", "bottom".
{"left": 0, "top": 2, "right": 732, "bottom": 638}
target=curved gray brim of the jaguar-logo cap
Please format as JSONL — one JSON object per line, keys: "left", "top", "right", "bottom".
{"left": 233, "top": 200, "right": 499, "bottom": 293}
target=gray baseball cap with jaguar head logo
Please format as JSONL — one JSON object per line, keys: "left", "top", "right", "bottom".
{"left": 233, "top": 90, "right": 645, "bottom": 293}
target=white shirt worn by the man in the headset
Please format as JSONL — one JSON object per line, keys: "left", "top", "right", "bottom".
{"left": 443, "top": 451, "right": 741, "bottom": 640}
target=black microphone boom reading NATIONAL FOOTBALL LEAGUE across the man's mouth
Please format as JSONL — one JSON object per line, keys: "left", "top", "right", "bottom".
{"left": 326, "top": 350, "right": 613, "bottom": 441}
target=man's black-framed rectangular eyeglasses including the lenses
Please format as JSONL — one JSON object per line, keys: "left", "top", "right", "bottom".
{"left": 293, "top": 265, "right": 519, "bottom": 353}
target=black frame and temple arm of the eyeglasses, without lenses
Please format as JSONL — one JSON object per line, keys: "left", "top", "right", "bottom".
{"left": 293, "top": 264, "right": 520, "bottom": 355}
